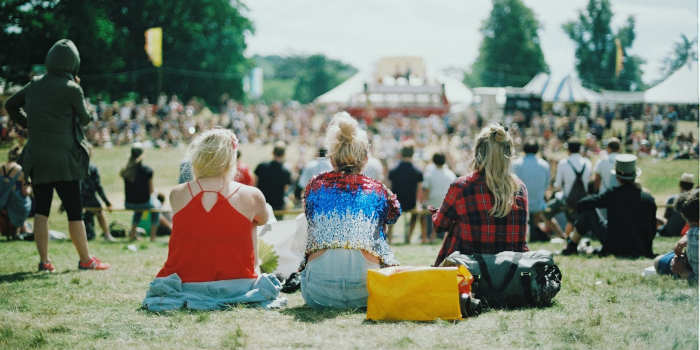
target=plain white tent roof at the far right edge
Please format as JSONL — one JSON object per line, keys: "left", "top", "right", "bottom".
{"left": 644, "top": 61, "right": 698, "bottom": 104}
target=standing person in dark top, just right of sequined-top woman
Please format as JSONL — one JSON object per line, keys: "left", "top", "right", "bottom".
{"left": 388, "top": 143, "right": 425, "bottom": 244}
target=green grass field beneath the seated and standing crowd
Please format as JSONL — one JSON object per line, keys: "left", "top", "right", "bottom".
{"left": 0, "top": 146, "right": 698, "bottom": 350}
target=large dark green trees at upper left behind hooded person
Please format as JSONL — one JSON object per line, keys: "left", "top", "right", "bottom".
{"left": 0, "top": 0, "right": 253, "bottom": 104}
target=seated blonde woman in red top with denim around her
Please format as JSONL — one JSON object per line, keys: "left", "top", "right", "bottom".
{"left": 143, "top": 129, "right": 281, "bottom": 311}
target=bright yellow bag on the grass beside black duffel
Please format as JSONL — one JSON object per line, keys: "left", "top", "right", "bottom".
{"left": 367, "top": 266, "right": 468, "bottom": 321}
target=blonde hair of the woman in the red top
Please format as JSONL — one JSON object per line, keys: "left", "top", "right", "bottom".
{"left": 188, "top": 128, "right": 238, "bottom": 178}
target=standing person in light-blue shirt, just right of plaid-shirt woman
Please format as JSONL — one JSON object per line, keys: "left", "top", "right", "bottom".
{"left": 513, "top": 141, "right": 562, "bottom": 242}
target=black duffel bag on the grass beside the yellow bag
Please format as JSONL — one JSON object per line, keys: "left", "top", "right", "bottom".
{"left": 442, "top": 250, "right": 561, "bottom": 307}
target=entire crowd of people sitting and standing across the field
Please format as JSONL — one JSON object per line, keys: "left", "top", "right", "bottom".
{"left": 0, "top": 40, "right": 698, "bottom": 311}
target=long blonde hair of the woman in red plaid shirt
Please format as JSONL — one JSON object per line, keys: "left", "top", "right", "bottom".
{"left": 472, "top": 124, "right": 518, "bottom": 217}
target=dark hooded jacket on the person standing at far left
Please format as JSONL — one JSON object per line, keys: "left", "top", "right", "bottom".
{"left": 5, "top": 39, "right": 91, "bottom": 184}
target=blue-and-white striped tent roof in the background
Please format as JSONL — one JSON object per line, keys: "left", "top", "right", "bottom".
{"left": 523, "top": 73, "right": 600, "bottom": 103}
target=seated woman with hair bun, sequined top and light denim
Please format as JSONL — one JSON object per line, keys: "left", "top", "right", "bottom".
{"left": 301, "top": 112, "right": 401, "bottom": 308}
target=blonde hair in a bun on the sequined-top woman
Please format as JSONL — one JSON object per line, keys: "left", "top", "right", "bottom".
{"left": 326, "top": 112, "right": 369, "bottom": 173}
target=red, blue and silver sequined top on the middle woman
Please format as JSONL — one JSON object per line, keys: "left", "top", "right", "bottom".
{"left": 304, "top": 171, "right": 401, "bottom": 265}
